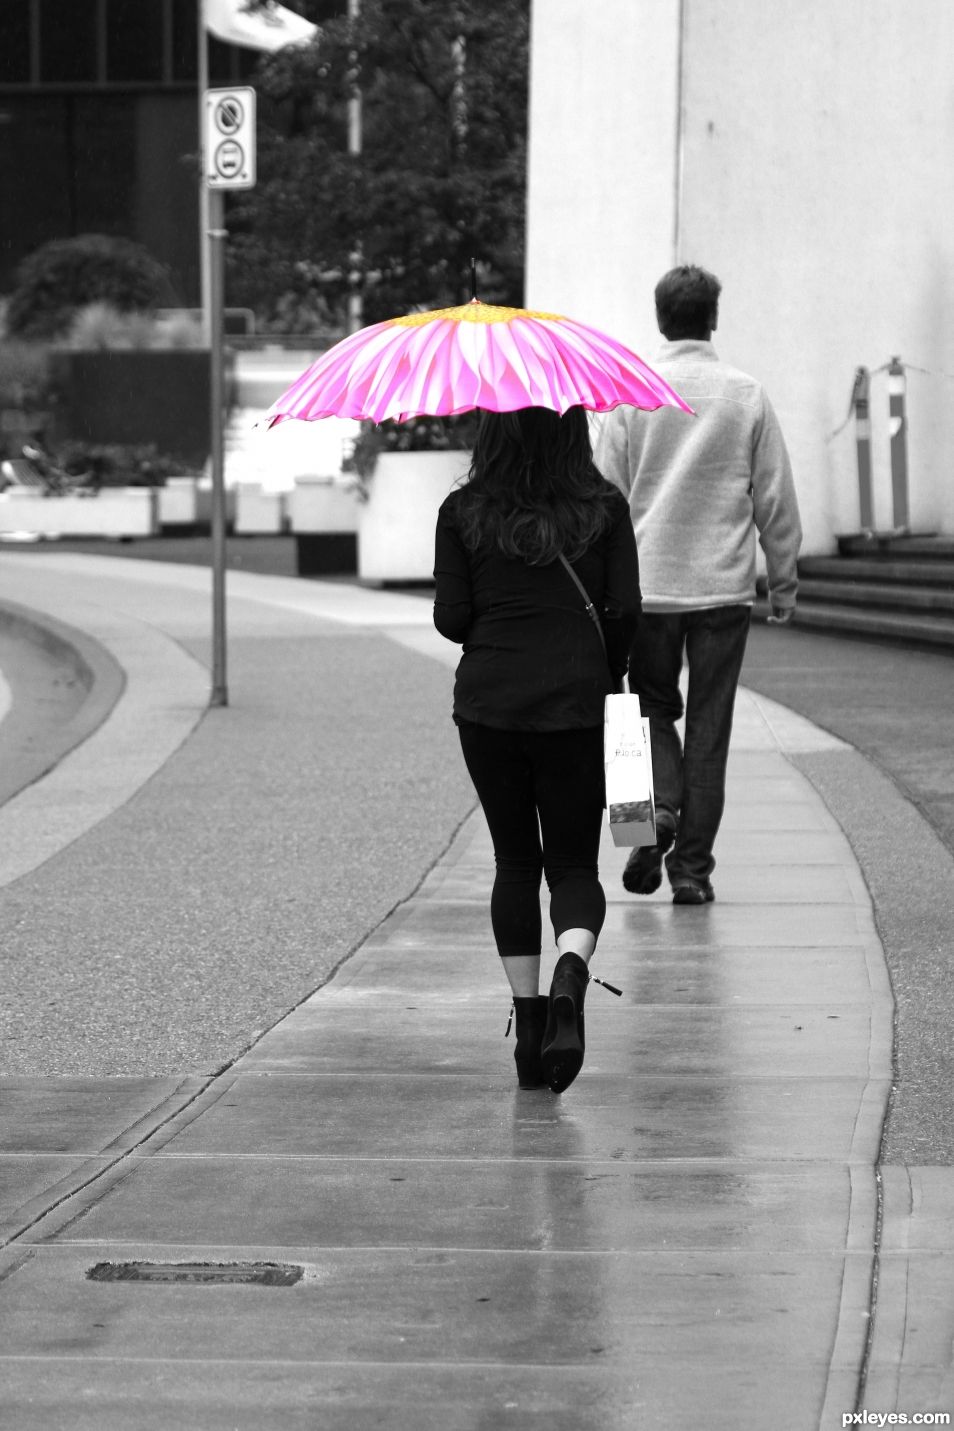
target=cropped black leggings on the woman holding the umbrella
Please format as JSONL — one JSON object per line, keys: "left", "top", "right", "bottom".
{"left": 458, "top": 721, "right": 606, "bottom": 959}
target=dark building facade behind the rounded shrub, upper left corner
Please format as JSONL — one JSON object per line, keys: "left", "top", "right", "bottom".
{"left": 0, "top": 0, "right": 338, "bottom": 306}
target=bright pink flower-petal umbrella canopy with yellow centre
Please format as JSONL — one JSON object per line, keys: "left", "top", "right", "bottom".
{"left": 265, "top": 298, "right": 692, "bottom": 426}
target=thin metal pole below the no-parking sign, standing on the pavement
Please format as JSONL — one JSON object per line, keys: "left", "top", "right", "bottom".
{"left": 209, "top": 189, "right": 229, "bottom": 705}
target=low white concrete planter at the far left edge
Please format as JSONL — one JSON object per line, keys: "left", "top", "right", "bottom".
{"left": 0, "top": 487, "right": 156, "bottom": 537}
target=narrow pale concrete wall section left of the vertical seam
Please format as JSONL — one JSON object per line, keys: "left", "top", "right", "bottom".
{"left": 525, "top": 0, "right": 679, "bottom": 346}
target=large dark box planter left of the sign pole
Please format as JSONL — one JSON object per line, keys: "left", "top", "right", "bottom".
{"left": 50, "top": 348, "right": 212, "bottom": 467}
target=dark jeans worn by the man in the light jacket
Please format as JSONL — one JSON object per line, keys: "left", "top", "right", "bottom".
{"left": 629, "top": 607, "right": 751, "bottom": 884}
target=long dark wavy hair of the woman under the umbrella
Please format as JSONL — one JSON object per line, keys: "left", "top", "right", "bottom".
{"left": 456, "top": 408, "right": 614, "bottom": 567}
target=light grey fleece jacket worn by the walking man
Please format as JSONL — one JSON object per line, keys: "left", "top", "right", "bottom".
{"left": 596, "top": 339, "right": 801, "bottom": 611}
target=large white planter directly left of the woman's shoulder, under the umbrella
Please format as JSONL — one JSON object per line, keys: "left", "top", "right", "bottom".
{"left": 358, "top": 452, "right": 471, "bottom": 581}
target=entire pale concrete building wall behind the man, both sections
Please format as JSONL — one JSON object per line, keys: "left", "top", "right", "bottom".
{"left": 528, "top": 0, "right": 954, "bottom": 554}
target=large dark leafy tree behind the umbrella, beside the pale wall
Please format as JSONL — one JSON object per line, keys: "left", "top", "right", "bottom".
{"left": 229, "top": 0, "right": 529, "bottom": 328}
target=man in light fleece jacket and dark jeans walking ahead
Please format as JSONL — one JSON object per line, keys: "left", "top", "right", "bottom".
{"left": 596, "top": 265, "right": 801, "bottom": 904}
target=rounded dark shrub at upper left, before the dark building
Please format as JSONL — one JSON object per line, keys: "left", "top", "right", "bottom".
{"left": 6, "top": 233, "right": 172, "bottom": 338}
